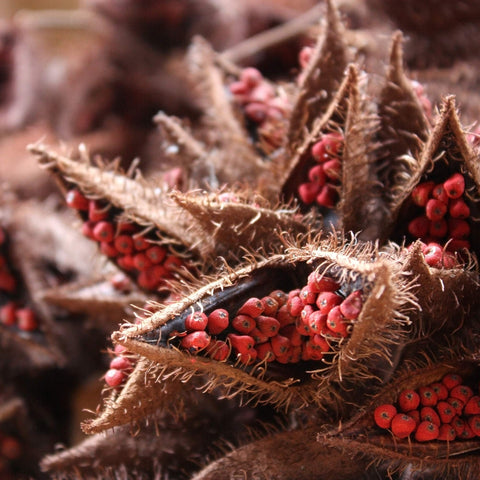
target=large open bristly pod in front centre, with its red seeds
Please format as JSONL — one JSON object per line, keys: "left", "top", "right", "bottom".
{"left": 104, "top": 238, "right": 415, "bottom": 424}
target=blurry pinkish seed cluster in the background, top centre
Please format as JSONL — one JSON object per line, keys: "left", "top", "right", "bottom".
{"left": 230, "top": 67, "right": 290, "bottom": 124}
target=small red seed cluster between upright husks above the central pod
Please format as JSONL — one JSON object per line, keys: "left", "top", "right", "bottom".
{"left": 298, "top": 132, "right": 343, "bottom": 208}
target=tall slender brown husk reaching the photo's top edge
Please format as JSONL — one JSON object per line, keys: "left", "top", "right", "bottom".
{"left": 287, "top": 1, "right": 349, "bottom": 151}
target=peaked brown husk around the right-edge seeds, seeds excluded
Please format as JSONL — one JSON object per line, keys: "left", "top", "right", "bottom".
{"left": 380, "top": 96, "right": 480, "bottom": 251}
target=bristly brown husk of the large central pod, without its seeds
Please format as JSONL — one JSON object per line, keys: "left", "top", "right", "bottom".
{"left": 112, "top": 237, "right": 416, "bottom": 416}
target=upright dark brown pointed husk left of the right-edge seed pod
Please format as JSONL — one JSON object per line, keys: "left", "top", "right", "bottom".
{"left": 375, "top": 32, "right": 429, "bottom": 201}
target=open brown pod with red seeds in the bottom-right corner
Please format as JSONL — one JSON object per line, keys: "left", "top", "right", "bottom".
{"left": 318, "top": 359, "right": 480, "bottom": 479}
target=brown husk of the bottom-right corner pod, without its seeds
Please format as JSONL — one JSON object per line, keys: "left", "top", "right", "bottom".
{"left": 317, "top": 359, "right": 480, "bottom": 480}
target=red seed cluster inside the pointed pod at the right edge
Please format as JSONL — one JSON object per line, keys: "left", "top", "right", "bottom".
{"left": 408, "top": 173, "right": 471, "bottom": 267}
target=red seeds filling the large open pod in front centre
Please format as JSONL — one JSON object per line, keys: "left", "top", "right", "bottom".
{"left": 175, "top": 272, "right": 363, "bottom": 364}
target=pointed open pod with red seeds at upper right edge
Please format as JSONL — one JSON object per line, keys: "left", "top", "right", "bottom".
{"left": 381, "top": 97, "right": 480, "bottom": 267}
